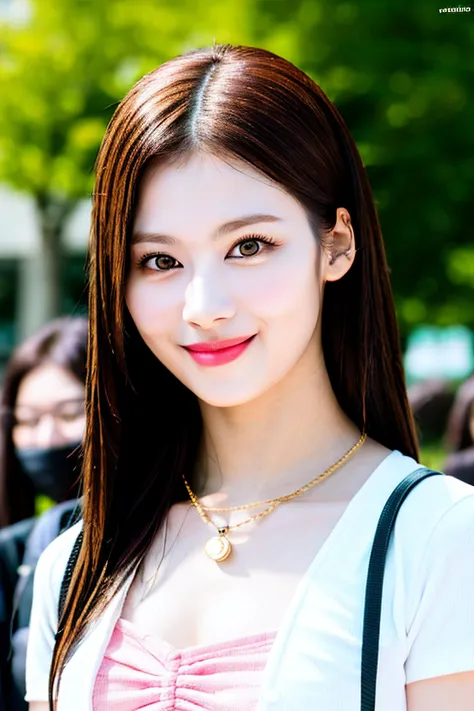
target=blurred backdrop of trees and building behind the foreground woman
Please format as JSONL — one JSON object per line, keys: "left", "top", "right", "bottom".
{"left": 0, "top": 0, "right": 474, "bottom": 466}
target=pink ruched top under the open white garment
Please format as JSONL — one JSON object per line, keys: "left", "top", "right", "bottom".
{"left": 93, "top": 619, "right": 276, "bottom": 711}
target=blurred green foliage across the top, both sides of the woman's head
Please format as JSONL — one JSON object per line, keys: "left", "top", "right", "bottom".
{"left": 0, "top": 0, "right": 474, "bottom": 333}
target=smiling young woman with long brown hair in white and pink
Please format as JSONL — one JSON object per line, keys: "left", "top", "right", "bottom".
{"left": 27, "top": 46, "right": 474, "bottom": 711}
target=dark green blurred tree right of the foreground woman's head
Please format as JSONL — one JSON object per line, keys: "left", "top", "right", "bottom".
{"left": 250, "top": 0, "right": 474, "bottom": 335}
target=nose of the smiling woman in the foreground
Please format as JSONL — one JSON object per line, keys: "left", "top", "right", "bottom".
{"left": 183, "top": 275, "right": 235, "bottom": 330}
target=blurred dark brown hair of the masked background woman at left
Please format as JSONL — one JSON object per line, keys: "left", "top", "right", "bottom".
{"left": 0, "top": 316, "right": 88, "bottom": 528}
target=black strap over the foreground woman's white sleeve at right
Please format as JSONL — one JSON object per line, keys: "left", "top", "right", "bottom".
{"left": 360, "top": 467, "right": 444, "bottom": 711}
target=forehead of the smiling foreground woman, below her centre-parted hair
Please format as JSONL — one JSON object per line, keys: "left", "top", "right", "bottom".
{"left": 133, "top": 152, "right": 302, "bottom": 234}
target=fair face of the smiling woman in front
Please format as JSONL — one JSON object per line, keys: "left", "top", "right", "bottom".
{"left": 126, "top": 153, "right": 334, "bottom": 407}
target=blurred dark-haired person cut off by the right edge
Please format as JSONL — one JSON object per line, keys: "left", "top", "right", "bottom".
{"left": 444, "top": 374, "right": 474, "bottom": 484}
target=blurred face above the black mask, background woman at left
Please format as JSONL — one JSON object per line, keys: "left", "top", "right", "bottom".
{"left": 12, "top": 363, "right": 86, "bottom": 449}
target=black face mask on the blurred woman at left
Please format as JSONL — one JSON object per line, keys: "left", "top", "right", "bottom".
{"left": 15, "top": 442, "right": 81, "bottom": 503}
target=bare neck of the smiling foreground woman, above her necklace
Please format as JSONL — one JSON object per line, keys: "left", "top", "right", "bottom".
{"left": 195, "top": 340, "right": 360, "bottom": 506}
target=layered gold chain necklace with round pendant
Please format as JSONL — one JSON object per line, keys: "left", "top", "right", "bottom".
{"left": 182, "top": 432, "right": 367, "bottom": 563}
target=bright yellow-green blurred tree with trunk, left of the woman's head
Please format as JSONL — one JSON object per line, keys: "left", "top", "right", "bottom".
{"left": 0, "top": 0, "right": 254, "bottom": 320}
